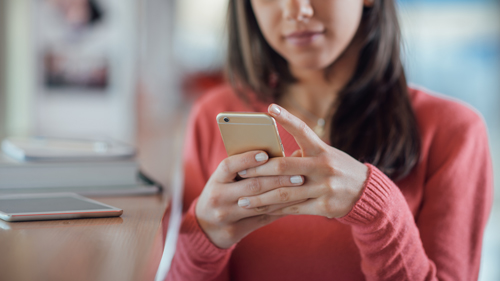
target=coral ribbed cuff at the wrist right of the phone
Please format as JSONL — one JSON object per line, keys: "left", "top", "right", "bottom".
{"left": 338, "top": 164, "right": 394, "bottom": 226}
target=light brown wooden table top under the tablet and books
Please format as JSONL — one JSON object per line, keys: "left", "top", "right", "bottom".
{"left": 0, "top": 194, "right": 169, "bottom": 281}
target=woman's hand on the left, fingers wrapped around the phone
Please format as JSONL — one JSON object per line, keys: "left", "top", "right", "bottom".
{"left": 195, "top": 151, "right": 304, "bottom": 249}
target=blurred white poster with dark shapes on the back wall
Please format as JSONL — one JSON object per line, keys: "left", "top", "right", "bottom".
{"left": 31, "top": 0, "right": 139, "bottom": 143}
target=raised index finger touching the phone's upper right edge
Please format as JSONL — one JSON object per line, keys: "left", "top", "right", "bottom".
{"left": 267, "top": 104, "right": 323, "bottom": 155}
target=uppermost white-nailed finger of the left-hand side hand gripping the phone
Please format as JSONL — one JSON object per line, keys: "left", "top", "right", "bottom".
{"left": 214, "top": 150, "right": 269, "bottom": 182}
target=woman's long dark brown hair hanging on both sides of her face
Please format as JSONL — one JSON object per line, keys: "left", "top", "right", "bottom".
{"left": 226, "top": 0, "right": 421, "bottom": 180}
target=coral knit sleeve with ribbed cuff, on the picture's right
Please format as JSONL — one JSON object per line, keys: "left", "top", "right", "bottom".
{"left": 339, "top": 112, "right": 493, "bottom": 280}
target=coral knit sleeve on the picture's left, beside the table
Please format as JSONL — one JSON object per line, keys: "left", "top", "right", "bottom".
{"left": 166, "top": 98, "right": 232, "bottom": 281}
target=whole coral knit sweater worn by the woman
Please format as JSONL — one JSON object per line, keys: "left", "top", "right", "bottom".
{"left": 167, "top": 86, "right": 493, "bottom": 281}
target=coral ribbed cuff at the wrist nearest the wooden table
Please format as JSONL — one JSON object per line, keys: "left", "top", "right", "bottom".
{"left": 179, "top": 198, "right": 235, "bottom": 262}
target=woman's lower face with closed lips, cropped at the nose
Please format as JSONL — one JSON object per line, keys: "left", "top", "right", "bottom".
{"left": 252, "top": 0, "right": 366, "bottom": 70}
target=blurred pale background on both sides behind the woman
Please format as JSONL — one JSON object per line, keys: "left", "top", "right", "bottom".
{"left": 0, "top": 0, "right": 500, "bottom": 276}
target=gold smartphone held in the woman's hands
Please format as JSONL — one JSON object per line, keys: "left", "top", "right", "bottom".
{"left": 217, "top": 112, "right": 285, "bottom": 157}
